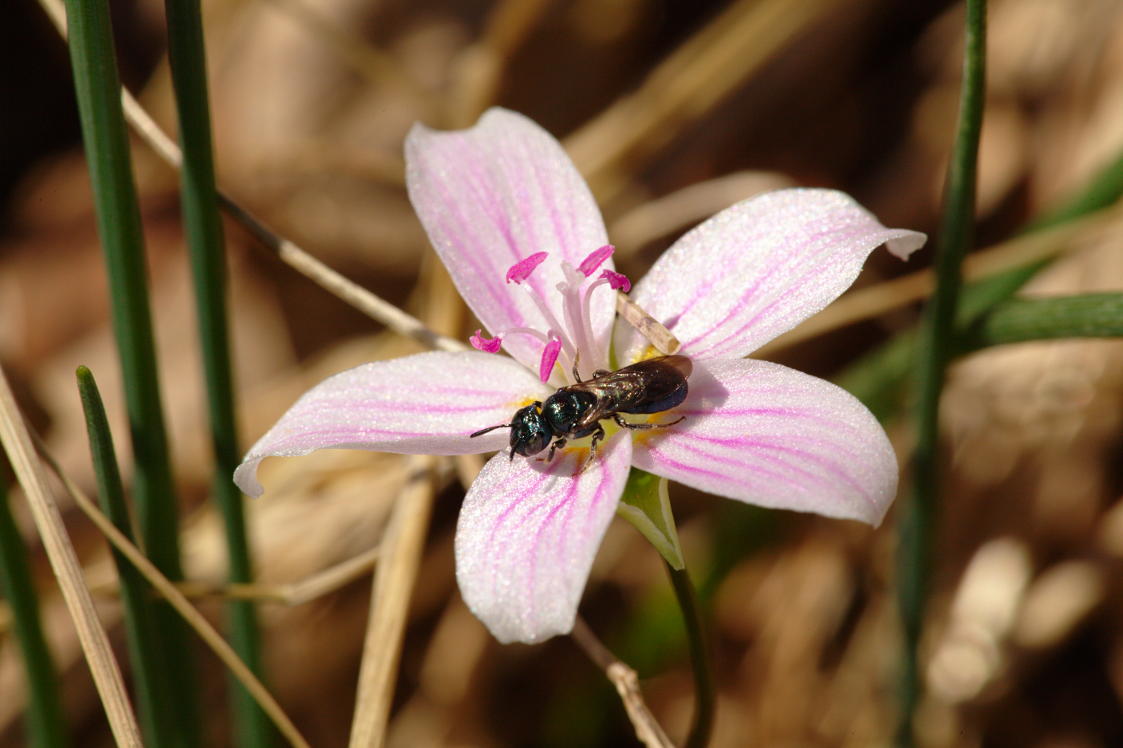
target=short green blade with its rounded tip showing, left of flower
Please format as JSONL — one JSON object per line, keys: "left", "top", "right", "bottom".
{"left": 76, "top": 366, "right": 175, "bottom": 746}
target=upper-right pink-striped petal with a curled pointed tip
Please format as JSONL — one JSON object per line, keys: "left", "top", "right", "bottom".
{"left": 617, "top": 190, "right": 925, "bottom": 364}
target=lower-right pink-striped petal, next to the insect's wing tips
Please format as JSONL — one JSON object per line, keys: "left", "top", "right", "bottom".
{"left": 632, "top": 358, "right": 897, "bottom": 526}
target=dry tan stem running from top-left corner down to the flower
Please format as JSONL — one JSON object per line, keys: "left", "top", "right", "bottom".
{"left": 39, "top": 0, "right": 467, "bottom": 350}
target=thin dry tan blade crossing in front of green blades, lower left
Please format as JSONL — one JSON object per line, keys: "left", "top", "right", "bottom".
{"left": 35, "top": 442, "right": 308, "bottom": 747}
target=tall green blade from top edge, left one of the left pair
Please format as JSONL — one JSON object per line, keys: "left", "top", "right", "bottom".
{"left": 60, "top": 0, "right": 200, "bottom": 746}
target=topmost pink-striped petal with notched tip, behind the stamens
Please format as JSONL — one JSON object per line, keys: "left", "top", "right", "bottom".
{"left": 405, "top": 109, "right": 615, "bottom": 367}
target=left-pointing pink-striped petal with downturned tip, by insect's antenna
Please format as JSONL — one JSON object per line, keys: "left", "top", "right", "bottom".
{"left": 234, "top": 350, "right": 551, "bottom": 496}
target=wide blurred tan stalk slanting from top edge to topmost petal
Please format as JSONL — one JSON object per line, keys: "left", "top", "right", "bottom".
{"left": 566, "top": 0, "right": 838, "bottom": 195}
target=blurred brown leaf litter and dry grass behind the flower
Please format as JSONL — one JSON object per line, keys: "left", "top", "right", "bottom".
{"left": 0, "top": 0, "right": 1123, "bottom": 748}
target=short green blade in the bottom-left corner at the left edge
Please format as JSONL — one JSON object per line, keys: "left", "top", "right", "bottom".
{"left": 0, "top": 471, "right": 66, "bottom": 748}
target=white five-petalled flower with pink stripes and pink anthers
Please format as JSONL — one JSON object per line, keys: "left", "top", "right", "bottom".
{"left": 235, "top": 109, "right": 924, "bottom": 642}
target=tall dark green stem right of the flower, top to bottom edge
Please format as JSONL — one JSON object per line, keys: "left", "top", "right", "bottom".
{"left": 897, "top": 0, "right": 986, "bottom": 746}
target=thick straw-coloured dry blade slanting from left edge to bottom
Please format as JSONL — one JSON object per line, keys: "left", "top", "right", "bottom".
{"left": 0, "top": 361, "right": 141, "bottom": 746}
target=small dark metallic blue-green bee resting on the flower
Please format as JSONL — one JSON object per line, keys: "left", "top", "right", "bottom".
{"left": 472, "top": 356, "right": 694, "bottom": 460}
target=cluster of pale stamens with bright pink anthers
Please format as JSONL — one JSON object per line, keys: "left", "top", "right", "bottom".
{"left": 469, "top": 244, "right": 631, "bottom": 382}
